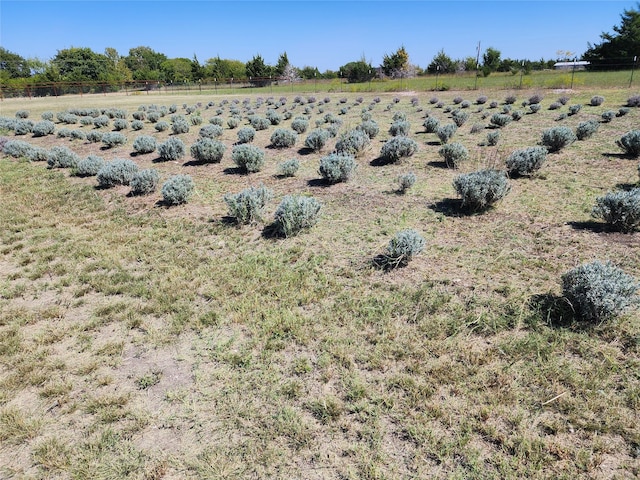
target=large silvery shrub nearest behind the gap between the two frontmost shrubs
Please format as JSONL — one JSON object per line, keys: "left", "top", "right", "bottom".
{"left": 453, "top": 170, "right": 510, "bottom": 211}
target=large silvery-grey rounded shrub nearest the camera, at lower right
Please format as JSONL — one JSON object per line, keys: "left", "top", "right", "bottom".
{"left": 562, "top": 261, "right": 640, "bottom": 323}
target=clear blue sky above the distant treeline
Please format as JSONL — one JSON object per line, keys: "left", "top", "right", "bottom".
{"left": 0, "top": 0, "right": 640, "bottom": 71}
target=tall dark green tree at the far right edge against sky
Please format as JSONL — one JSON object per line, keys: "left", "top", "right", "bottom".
{"left": 582, "top": 3, "right": 640, "bottom": 69}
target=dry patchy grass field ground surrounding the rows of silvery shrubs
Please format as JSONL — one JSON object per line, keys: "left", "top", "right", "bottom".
{"left": 0, "top": 89, "right": 640, "bottom": 479}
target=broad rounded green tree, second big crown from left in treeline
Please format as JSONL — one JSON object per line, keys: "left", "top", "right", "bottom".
{"left": 51, "top": 47, "right": 109, "bottom": 82}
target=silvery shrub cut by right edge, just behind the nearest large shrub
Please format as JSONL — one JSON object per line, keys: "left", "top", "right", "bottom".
{"left": 591, "top": 188, "right": 640, "bottom": 233}
